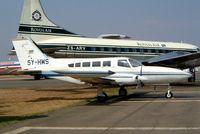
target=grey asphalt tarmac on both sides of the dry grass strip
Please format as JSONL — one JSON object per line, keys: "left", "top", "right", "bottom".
{"left": 0, "top": 79, "right": 200, "bottom": 134}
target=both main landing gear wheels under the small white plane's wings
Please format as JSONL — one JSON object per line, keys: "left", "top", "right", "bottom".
{"left": 97, "top": 86, "right": 128, "bottom": 102}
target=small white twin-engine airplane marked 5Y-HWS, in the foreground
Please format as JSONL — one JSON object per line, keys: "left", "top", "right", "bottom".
{"left": 13, "top": 39, "right": 191, "bottom": 101}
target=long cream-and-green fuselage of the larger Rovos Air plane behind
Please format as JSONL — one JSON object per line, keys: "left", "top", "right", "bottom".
{"left": 18, "top": 33, "right": 199, "bottom": 61}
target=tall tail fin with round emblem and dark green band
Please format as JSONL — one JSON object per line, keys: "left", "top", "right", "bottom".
{"left": 18, "top": 0, "right": 80, "bottom": 41}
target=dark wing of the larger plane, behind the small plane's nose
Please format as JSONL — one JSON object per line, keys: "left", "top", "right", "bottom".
{"left": 143, "top": 51, "right": 200, "bottom": 69}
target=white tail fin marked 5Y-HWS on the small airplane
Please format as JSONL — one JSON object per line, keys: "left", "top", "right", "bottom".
{"left": 12, "top": 39, "right": 51, "bottom": 70}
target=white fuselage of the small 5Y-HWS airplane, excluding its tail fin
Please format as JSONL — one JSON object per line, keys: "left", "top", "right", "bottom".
{"left": 30, "top": 57, "right": 190, "bottom": 86}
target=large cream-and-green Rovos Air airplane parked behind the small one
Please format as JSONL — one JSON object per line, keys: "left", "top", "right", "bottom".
{"left": 12, "top": 0, "right": 200, "bottom": 80}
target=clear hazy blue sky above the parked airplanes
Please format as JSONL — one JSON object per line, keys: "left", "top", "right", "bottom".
{"left": 0, "top": 0, "right": 200, "bottom": 61}
